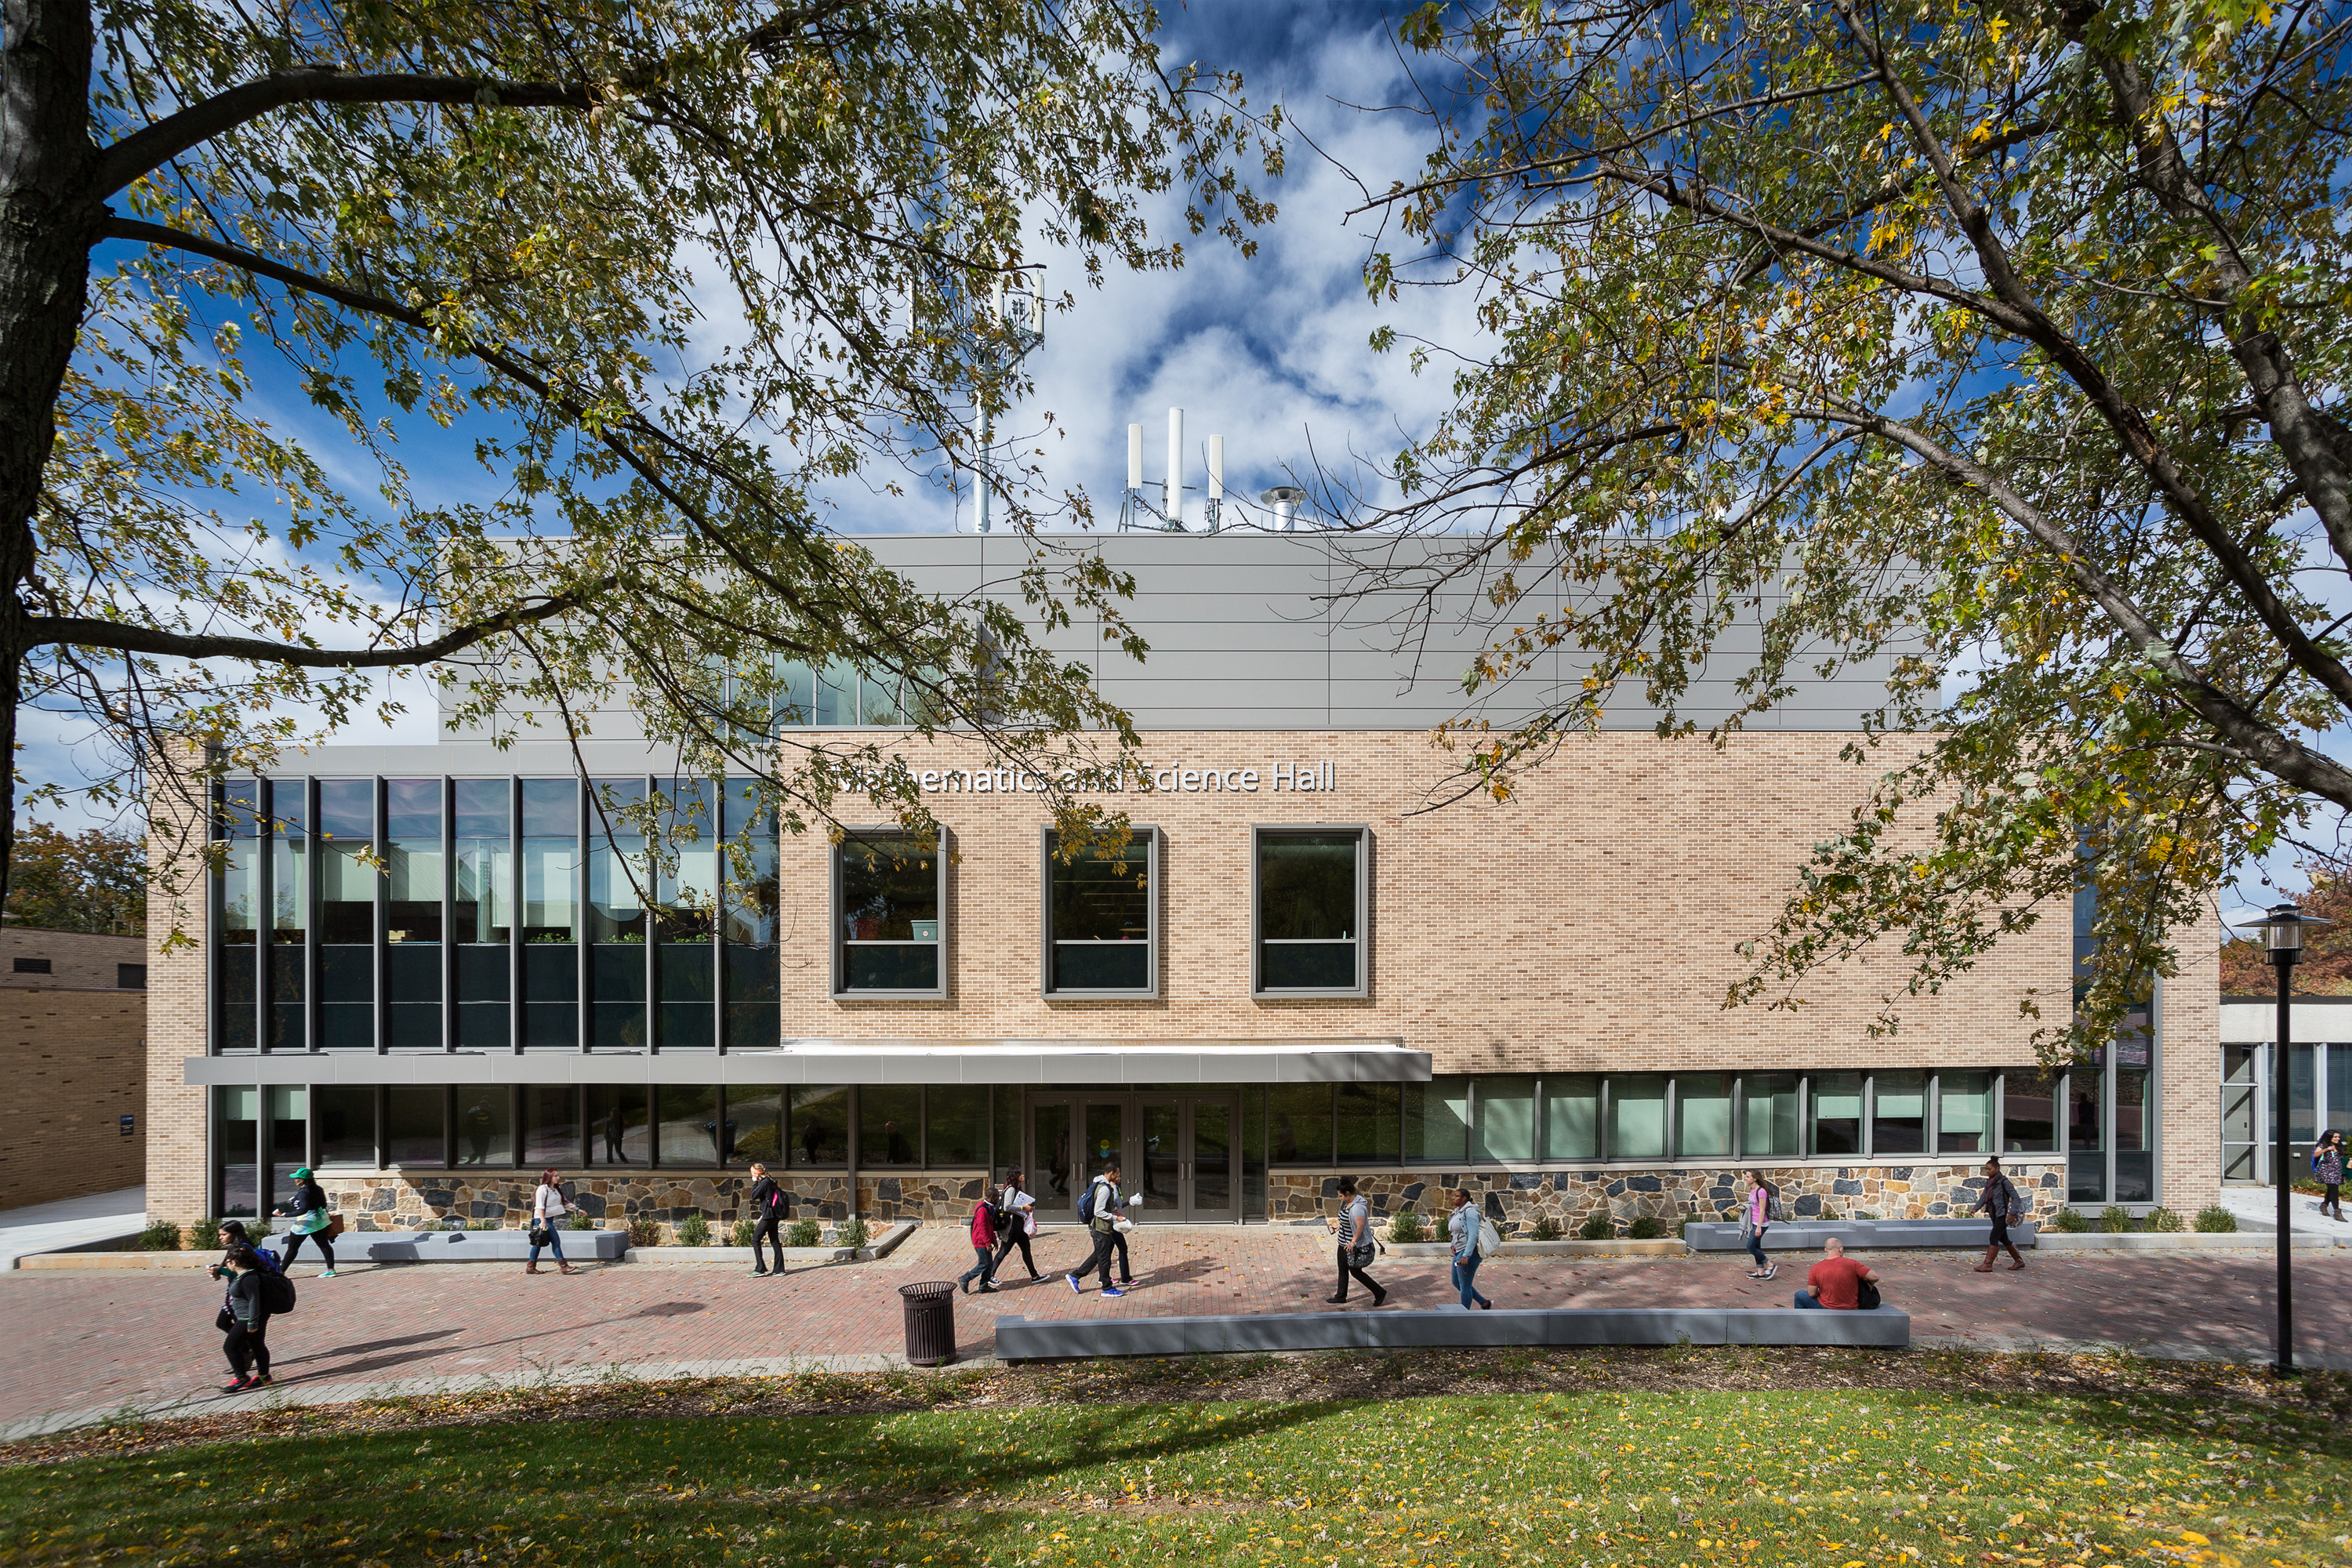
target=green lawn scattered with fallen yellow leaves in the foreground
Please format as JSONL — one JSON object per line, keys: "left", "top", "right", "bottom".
{"left": 0, "top": 1387, "right": 2352, "bottom": 1568}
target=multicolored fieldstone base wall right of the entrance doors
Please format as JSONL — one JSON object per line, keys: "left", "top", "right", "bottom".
{"left": 1265, "top": 1161, "right": 2065, "bottom": 1236}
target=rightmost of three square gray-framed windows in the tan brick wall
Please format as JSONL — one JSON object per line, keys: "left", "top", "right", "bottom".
{"left": 1251, "top": 827, "right": 1371, "bottom": 996}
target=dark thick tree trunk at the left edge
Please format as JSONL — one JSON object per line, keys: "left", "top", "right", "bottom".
{"left": 0, "top": 0, "right": 106, "bottom": 902}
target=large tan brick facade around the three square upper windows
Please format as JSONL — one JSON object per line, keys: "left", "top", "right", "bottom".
{"left": 781, "top": 731, "right": 2072, "bottom": 1072}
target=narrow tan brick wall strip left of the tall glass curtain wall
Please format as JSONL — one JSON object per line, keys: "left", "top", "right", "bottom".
{"left": 146, "top": 789, "right": 212, "bottom": 1225}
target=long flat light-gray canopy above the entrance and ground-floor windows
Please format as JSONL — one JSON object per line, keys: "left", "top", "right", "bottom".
{"left": 186, "top": 1036, "right": 1430, "bottom": 1086}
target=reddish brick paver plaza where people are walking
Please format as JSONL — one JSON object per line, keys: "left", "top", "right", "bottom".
{"left": 0, "top": 1227, "right": 2352, "bottom": 1427}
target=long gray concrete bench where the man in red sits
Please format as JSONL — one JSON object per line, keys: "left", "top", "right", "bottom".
{"left": 997, "top": 1302, "right": 1910, "bottom": 1361}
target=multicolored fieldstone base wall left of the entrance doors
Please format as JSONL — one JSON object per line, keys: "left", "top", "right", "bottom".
{"left": 318, "top": 1171, "right": 873, "bottom": 1229}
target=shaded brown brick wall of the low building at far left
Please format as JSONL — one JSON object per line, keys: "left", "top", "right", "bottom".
{"left": 0, "top": 985, "right": 146, "bottom": 1208}
